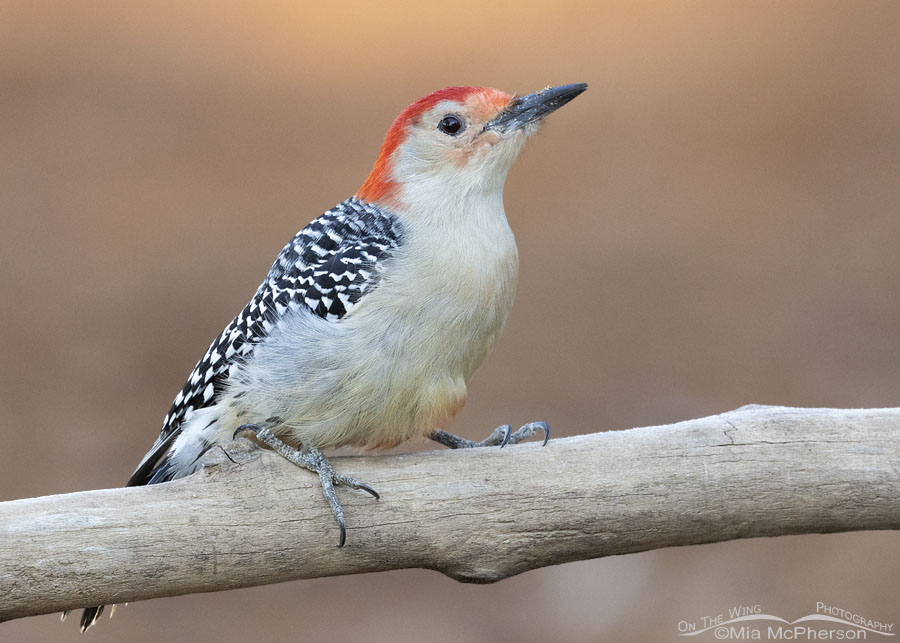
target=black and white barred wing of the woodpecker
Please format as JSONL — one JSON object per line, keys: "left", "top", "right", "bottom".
{"left": 128, "top": 198, "right": 402, "bottom": 485}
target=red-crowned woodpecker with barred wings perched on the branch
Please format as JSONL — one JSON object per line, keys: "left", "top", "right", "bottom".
{"left": 70, "top": 83, "right": 587, "bottom": 631}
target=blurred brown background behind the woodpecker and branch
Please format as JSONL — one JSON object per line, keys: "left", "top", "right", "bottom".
{"left": 0, "top": 0, "right": 900, "bottom": 643}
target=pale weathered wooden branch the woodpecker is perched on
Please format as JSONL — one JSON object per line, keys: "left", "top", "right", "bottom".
{"left": 0, "top": 406, "right": 900, "bottom": 621}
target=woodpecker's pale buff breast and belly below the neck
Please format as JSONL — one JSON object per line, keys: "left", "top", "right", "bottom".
{"left": 214, "top": 206, "right": 517, "bottom": 448}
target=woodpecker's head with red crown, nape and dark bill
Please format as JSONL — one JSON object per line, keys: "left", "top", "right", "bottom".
{"left": 357, "top": 83, "right": 587, "bottom": 206}
